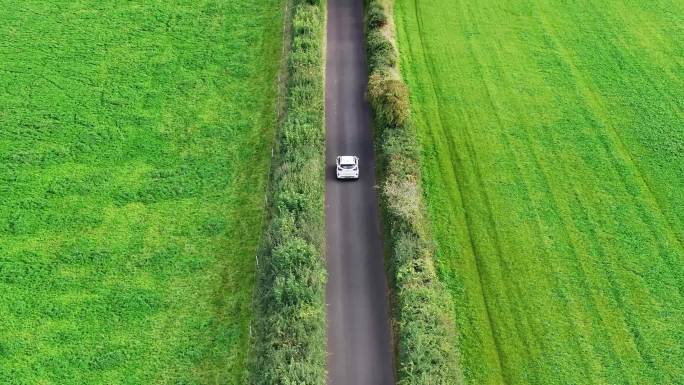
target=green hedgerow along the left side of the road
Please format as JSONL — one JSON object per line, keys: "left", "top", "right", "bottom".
{"left": 250, "top": 0, "right": 326, "bottom": 385}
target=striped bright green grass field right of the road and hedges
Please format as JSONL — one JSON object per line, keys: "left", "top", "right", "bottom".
{"left": 395, "top": 0, "right": 684, "bottom": 384}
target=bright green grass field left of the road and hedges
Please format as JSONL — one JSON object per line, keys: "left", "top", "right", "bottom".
{"left": 0, "top": 0, "right": 283, "bottom": 385}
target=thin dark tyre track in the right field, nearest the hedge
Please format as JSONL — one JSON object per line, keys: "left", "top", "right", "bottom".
{"left": 406, "top": 0, "right": 507, "bottom": 384}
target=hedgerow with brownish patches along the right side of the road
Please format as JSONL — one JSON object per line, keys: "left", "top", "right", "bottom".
{"left": 366, "top": 0, "right": 462, "bottom": 385}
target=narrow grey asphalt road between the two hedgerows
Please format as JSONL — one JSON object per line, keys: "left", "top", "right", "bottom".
{"left": 325, "top": 0, "right": 395, "bottom": 385}
